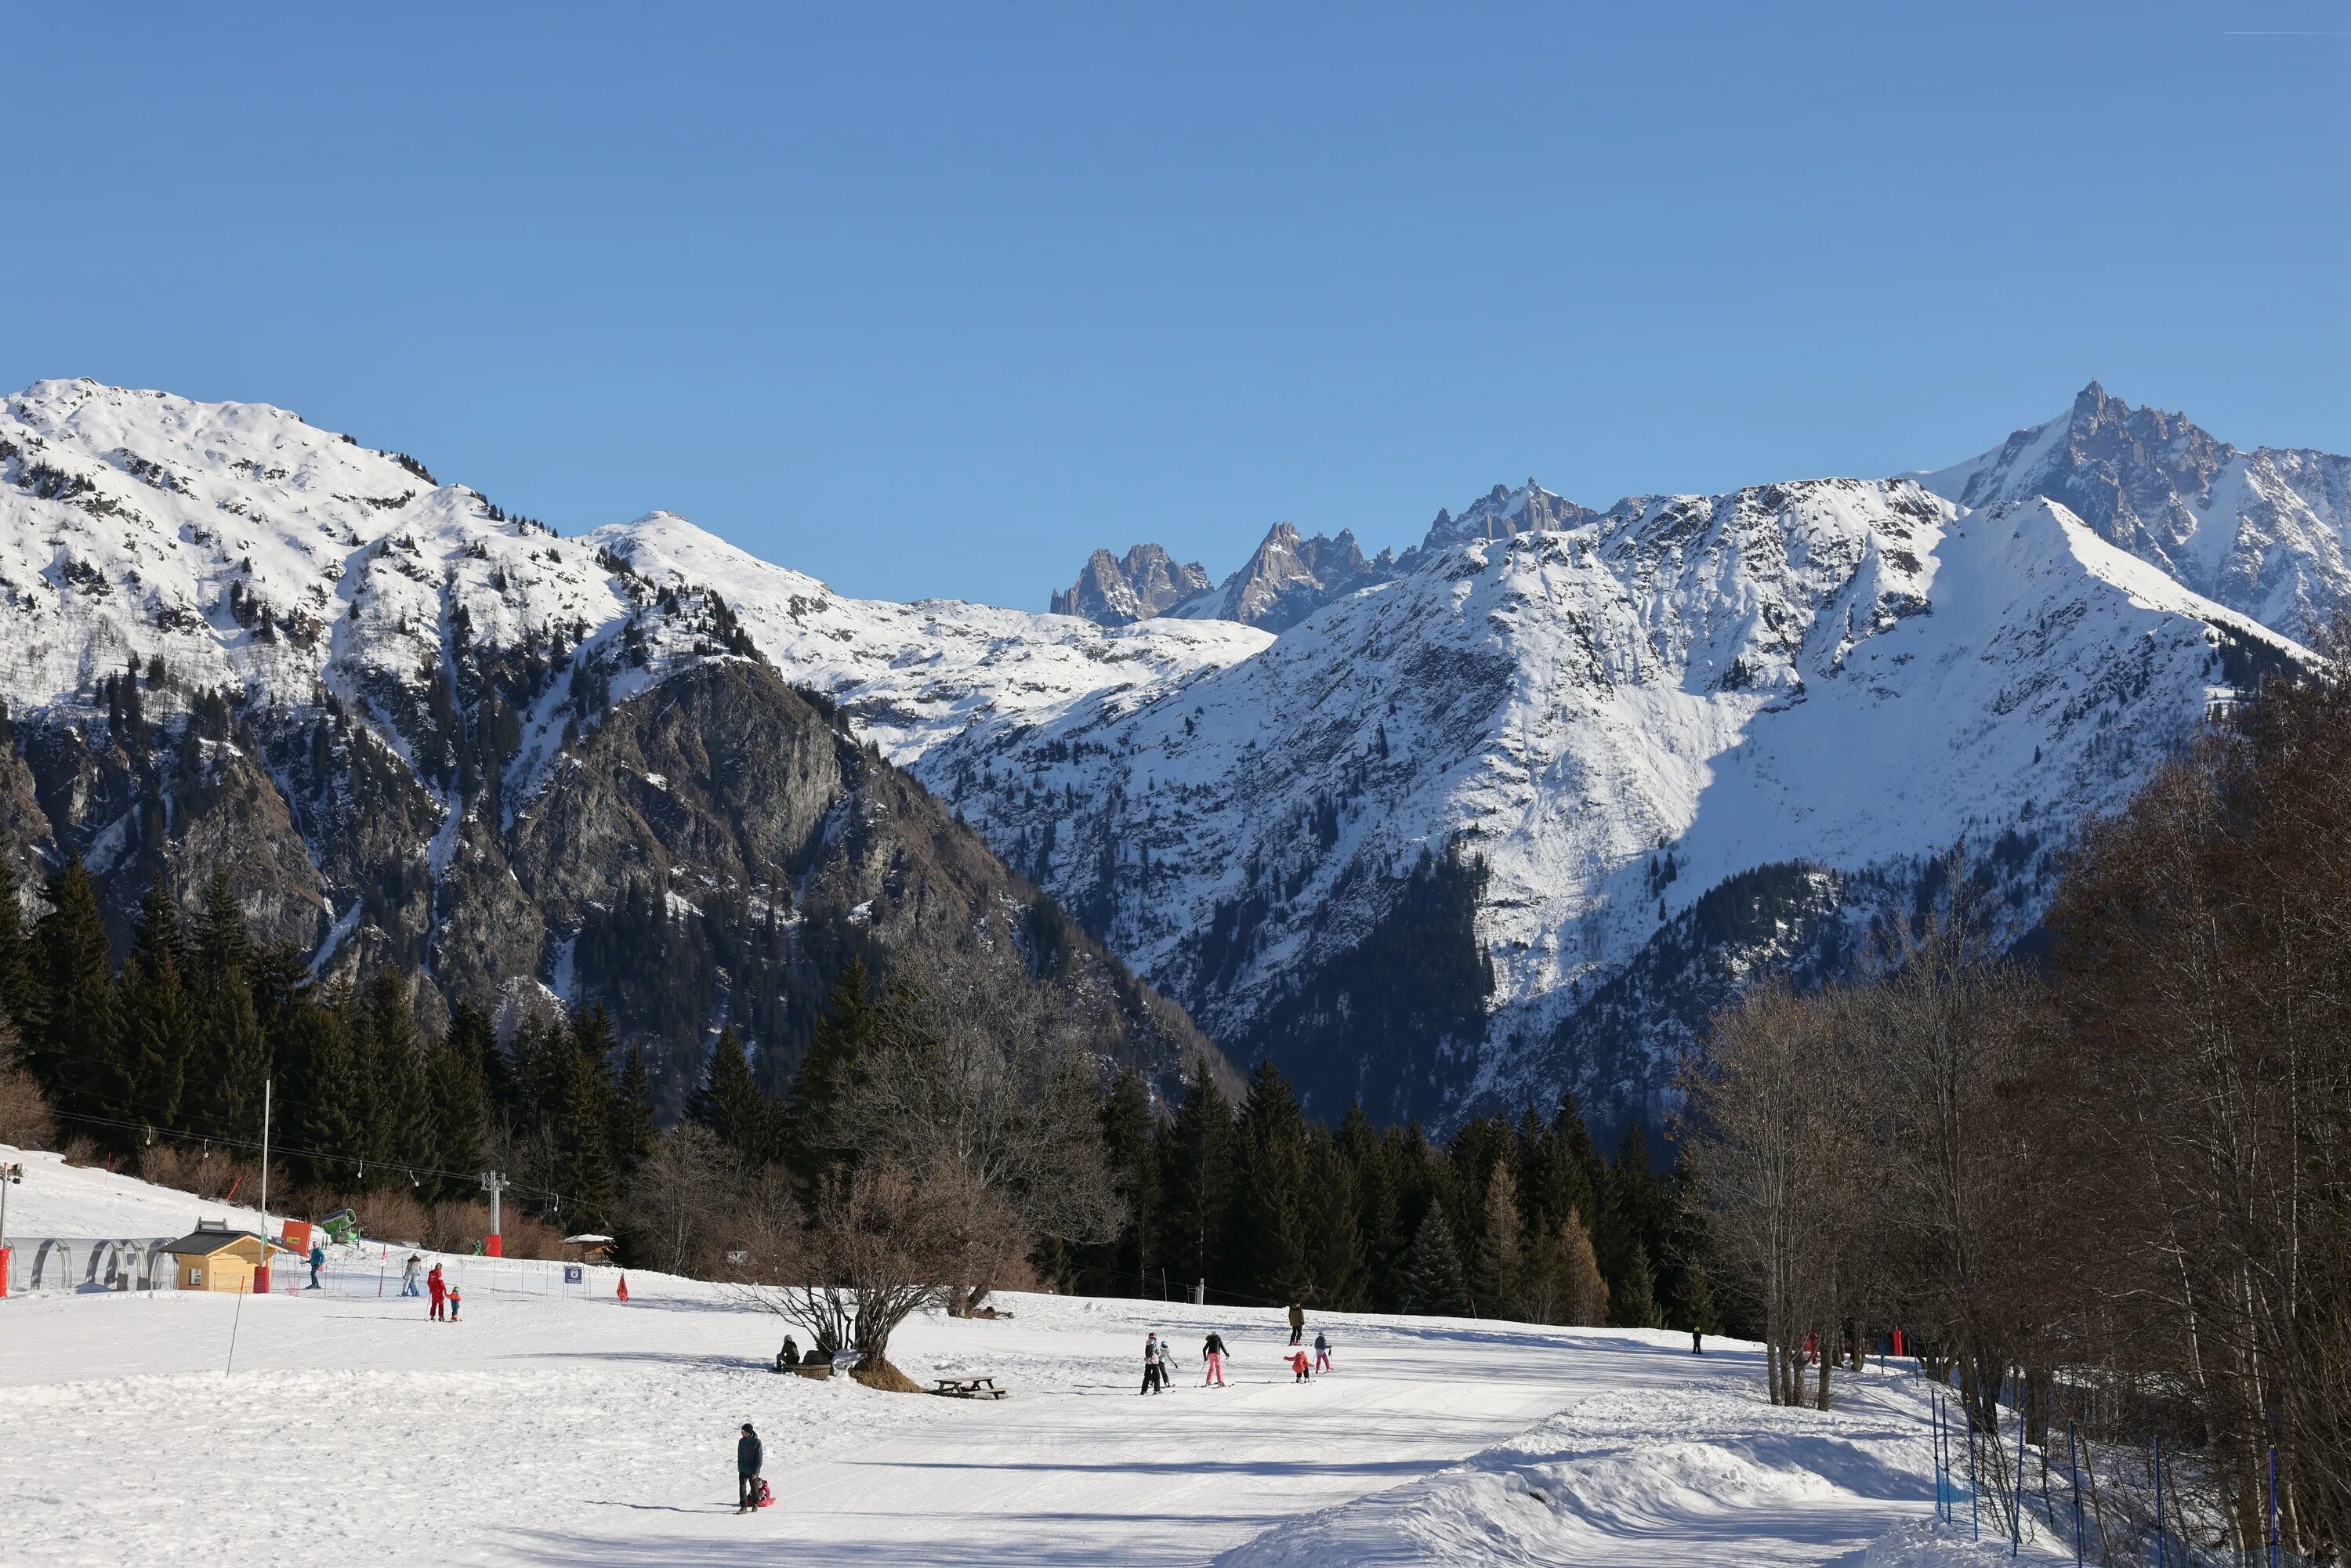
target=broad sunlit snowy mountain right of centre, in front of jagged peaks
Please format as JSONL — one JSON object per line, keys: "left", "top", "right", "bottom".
{"left": 889, "top": 480, "right": 2304, "bottom": 1117}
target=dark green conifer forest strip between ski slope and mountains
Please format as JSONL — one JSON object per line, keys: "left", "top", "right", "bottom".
{"left": 0, "top": 863, "right": 1716, "bottom": 1331}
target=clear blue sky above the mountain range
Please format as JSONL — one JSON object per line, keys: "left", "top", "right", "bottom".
{"left": 0, "top": 0, "right": 2351, "bottom": 609}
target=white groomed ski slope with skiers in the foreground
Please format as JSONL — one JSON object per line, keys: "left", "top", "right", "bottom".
{"left": 0, "top": 1154, "right": 2050, "bottom": 1568}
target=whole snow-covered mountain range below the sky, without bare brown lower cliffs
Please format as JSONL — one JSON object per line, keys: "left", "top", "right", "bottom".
{"left": 0, "top": 381, "right": 2313, "bottom": 1121}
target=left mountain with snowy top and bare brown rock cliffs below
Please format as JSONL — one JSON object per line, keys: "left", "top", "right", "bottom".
{"left": 0, "top": 383, "right": 1230, "bottom": 1107}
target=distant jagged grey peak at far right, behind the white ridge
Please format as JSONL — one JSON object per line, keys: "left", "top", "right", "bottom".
{"left": 1923, "top": 381, "right": 2351, "bottom": 637}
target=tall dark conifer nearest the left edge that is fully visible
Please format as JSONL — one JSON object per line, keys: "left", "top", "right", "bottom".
{"left": 24, "top": 858, "right": 132, "bottom": 1147}
